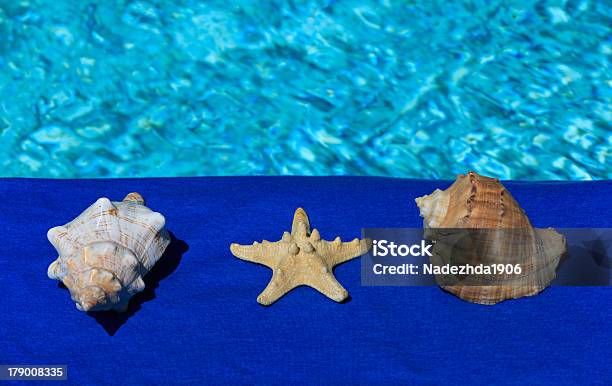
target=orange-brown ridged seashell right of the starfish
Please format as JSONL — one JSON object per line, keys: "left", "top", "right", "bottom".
{"left": 416, "top": 172, "right": 566, "bottom": 304}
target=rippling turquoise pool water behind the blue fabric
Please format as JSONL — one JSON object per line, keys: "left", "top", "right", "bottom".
{"left": 0, "top": 0, "right": 612, "bottom": 180}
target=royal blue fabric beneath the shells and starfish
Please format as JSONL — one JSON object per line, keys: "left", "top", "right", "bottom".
{"left": 0, "top": 177, "right": 612, "bottom": 385}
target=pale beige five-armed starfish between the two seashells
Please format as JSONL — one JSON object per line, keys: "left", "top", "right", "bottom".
{"left": 230, "top": 208, "right": 372, "bottom": 306}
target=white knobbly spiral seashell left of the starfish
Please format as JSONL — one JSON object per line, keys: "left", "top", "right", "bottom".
{"left": 47, "top": 193, "right": 170, "bottom": 312}
